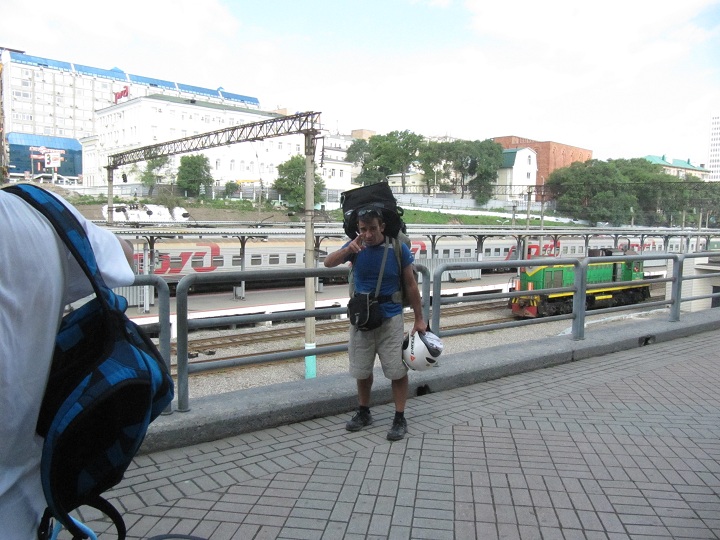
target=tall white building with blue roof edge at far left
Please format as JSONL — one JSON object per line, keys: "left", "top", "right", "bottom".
{"left": 0, "top": 49, "right": 260, "bottom": 178}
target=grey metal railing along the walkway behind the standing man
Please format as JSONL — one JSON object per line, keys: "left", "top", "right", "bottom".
{"left": 162, "top": 252, "right": 720, "bottom": 412}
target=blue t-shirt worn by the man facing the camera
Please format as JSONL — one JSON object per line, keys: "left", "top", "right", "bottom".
{"left": 343, "top": 235, "right": 415, "bottom": 319}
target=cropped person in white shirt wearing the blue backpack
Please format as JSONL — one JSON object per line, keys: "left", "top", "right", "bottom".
{"left": 0, "top": 190, "right": 134, "bottom": 540}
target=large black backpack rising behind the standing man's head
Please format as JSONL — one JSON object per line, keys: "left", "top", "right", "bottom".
{"left": 340, "top": 182, "right": 406, "bottom": 239}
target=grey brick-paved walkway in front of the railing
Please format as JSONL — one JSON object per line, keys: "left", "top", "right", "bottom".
{"left": 71, "top": 324, "right": 720, "bottom": 540}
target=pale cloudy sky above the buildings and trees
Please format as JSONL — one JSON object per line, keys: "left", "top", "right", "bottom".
{"left": 0, "top": 0, "right": 720, "bottom": 165}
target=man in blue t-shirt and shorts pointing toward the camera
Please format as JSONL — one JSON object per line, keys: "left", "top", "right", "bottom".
{"left": 325, "top": 206, "right": 427, "bottom": 441}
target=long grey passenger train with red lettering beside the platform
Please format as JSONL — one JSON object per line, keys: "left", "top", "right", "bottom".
{"left": 126, "top": 232, "right": 704, "bottom": 287}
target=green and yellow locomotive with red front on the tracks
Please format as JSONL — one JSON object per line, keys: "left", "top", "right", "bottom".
{"left": 510, "top": 249, "right": 650, "bottom": 318}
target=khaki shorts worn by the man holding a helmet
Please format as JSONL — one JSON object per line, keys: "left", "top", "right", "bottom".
{"left": 348, "top": 314, "right": 407, "bottom": 381}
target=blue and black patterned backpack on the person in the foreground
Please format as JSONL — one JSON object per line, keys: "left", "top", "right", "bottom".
{"left": 5, "top": 184, "right": 174, "bottom": 539}
